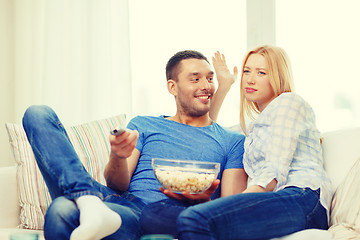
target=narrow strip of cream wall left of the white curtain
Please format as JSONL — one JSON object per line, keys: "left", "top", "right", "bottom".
{"left": 0, "top": 0, "right": 14, "bottom": 167}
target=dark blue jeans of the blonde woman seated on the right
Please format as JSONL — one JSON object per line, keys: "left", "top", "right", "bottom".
{"left": 177, "top": 187, "right": 328, "bottom": 240}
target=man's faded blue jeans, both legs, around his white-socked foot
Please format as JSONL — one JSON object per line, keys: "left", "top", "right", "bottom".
{"left": 23, "top": 106, "right": 145, "bottom": 240}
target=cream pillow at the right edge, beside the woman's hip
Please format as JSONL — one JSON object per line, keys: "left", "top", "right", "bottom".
{"left": 329, "top": 159, "right": 360, "bottom": 239}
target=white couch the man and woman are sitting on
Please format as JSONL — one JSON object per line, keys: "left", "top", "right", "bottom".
{"left": 0, "top": 128, "right": 360, "bottom": 240}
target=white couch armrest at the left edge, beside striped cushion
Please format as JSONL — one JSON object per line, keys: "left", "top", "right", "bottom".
{"left": 0, "top": 166, "right": 20, "bottom": 228}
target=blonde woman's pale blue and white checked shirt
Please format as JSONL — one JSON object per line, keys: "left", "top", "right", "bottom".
{"left": 243, "top": 93, "right": 332, "bottom": 216}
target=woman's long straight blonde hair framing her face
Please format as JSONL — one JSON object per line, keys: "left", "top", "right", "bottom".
{"left": 240, "top": 45, "right": 294, "bottom": 135}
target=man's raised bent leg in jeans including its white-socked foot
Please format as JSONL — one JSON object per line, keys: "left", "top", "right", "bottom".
{"left": 23, "top": 106, "right": 121, "bottom": 240}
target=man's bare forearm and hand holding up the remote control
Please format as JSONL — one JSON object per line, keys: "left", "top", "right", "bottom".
{"left": 104, "top": 130, "right": 140, "bottom": 191}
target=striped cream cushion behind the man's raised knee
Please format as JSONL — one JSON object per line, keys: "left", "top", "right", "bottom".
{"left": 6, "top": 114, "right": 125, "bottom": 229}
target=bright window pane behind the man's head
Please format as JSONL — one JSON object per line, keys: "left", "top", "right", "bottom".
{"left": 129, "top": 0, "right": 246, "bottom": 126}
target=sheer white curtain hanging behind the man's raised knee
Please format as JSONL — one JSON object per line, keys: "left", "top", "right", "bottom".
{"left": 13, "top": 0, "right": 131, "bottom": 124}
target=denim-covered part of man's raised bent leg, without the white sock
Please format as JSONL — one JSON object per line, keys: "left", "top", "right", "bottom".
{"left": 23, "top": 106, "right": 102, "bottom": 199}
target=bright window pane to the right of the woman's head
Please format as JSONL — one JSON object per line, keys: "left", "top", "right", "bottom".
{"left": 276, "top": 0, "right": 360, "bottom": 131}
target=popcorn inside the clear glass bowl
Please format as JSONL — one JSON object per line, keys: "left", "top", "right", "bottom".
{"left": 154, "top": 167, "right": 217, "bottom": 193}
